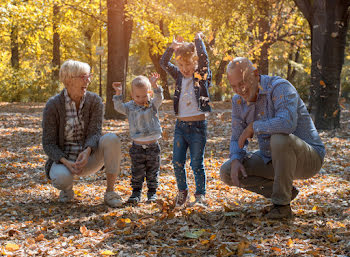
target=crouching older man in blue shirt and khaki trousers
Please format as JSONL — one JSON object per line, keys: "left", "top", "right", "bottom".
{"left": 220, "top": 57, "right": 325, "bottom": 219}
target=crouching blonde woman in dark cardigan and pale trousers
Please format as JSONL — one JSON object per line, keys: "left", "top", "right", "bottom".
{"left": 42, "top": 60, "right": 122, "bottom": 207}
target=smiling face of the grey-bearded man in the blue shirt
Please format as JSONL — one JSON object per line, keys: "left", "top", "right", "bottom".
{"left": 227, "top": 66, "right": 259, "bottom": 102}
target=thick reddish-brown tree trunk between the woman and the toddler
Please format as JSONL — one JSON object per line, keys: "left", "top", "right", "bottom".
{"left": 105, "top": 0, "right": 132, "bottom": 119}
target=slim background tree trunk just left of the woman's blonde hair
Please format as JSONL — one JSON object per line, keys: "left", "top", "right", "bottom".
{"left": 51, "top": 3, "right": 61, "bottom": 94}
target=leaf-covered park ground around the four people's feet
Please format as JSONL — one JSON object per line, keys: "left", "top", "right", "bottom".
{"left": 0, "top": 102, "right": 350, "bottom": 256}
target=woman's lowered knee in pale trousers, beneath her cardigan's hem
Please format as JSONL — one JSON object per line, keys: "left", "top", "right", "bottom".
{"left": 50, "top": 164, "right": 73, "bottom": 190}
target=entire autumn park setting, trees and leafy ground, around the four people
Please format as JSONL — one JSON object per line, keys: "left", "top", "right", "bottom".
{"left": 0, "top": 0, "right": 350, "bottom": 257}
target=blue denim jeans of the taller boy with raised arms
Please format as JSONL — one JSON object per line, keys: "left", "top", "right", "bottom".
{"left": 173, "top": 120, "right": 207, "bottom": 195}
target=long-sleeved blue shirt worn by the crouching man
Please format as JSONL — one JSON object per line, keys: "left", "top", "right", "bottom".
{"left": 230, "top": 75, "right": 326, "bottom": 163}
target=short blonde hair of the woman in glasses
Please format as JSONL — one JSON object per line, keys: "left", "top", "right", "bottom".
{"left": 59, "top": 60, "right": 91, "bottom": 85}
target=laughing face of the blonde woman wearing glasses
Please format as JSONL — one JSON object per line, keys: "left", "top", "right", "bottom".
{"left": 65, "top": 72, "right": 92, "bottom": 100}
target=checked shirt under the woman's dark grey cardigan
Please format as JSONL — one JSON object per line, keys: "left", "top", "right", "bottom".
{"left": 64, "top": 89, "right": 85, "bottom": 161}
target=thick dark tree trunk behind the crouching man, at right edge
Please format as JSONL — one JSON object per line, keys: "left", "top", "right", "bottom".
{"left": 294, "top": 0, "right": 350, "bottom": 130}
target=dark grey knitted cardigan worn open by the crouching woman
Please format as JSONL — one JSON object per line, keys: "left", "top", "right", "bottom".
{"left": 42, "top": 91, "right": 103, "bottom": 178}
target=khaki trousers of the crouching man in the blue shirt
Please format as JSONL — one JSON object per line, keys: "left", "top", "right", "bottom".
{"left": 220, "top": 134, "right": 322, "bottom": 205}
